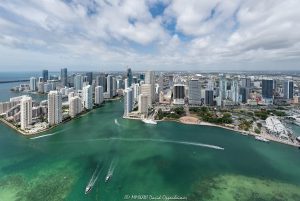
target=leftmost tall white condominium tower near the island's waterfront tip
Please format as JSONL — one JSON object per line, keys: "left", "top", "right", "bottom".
{"left": 20, "top": 96, "right": 32, "bottom": 130}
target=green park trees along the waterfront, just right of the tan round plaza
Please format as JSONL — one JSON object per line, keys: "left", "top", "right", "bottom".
{"left": 190, "top": 107, "right": 233, "bottom": 124}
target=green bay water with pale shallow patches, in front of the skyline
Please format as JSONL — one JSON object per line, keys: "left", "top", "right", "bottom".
{"left": 0, "top": 101, "right": 300, "bottom": 201}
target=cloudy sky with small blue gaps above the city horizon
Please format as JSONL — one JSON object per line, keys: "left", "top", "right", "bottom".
{"left": 0, "top": 0, "right": 300, "bottom": 71}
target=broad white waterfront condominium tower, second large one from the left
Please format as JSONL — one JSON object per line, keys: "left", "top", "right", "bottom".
{"left": 48, "top": 91, "right": 62, "bottom": 126}
